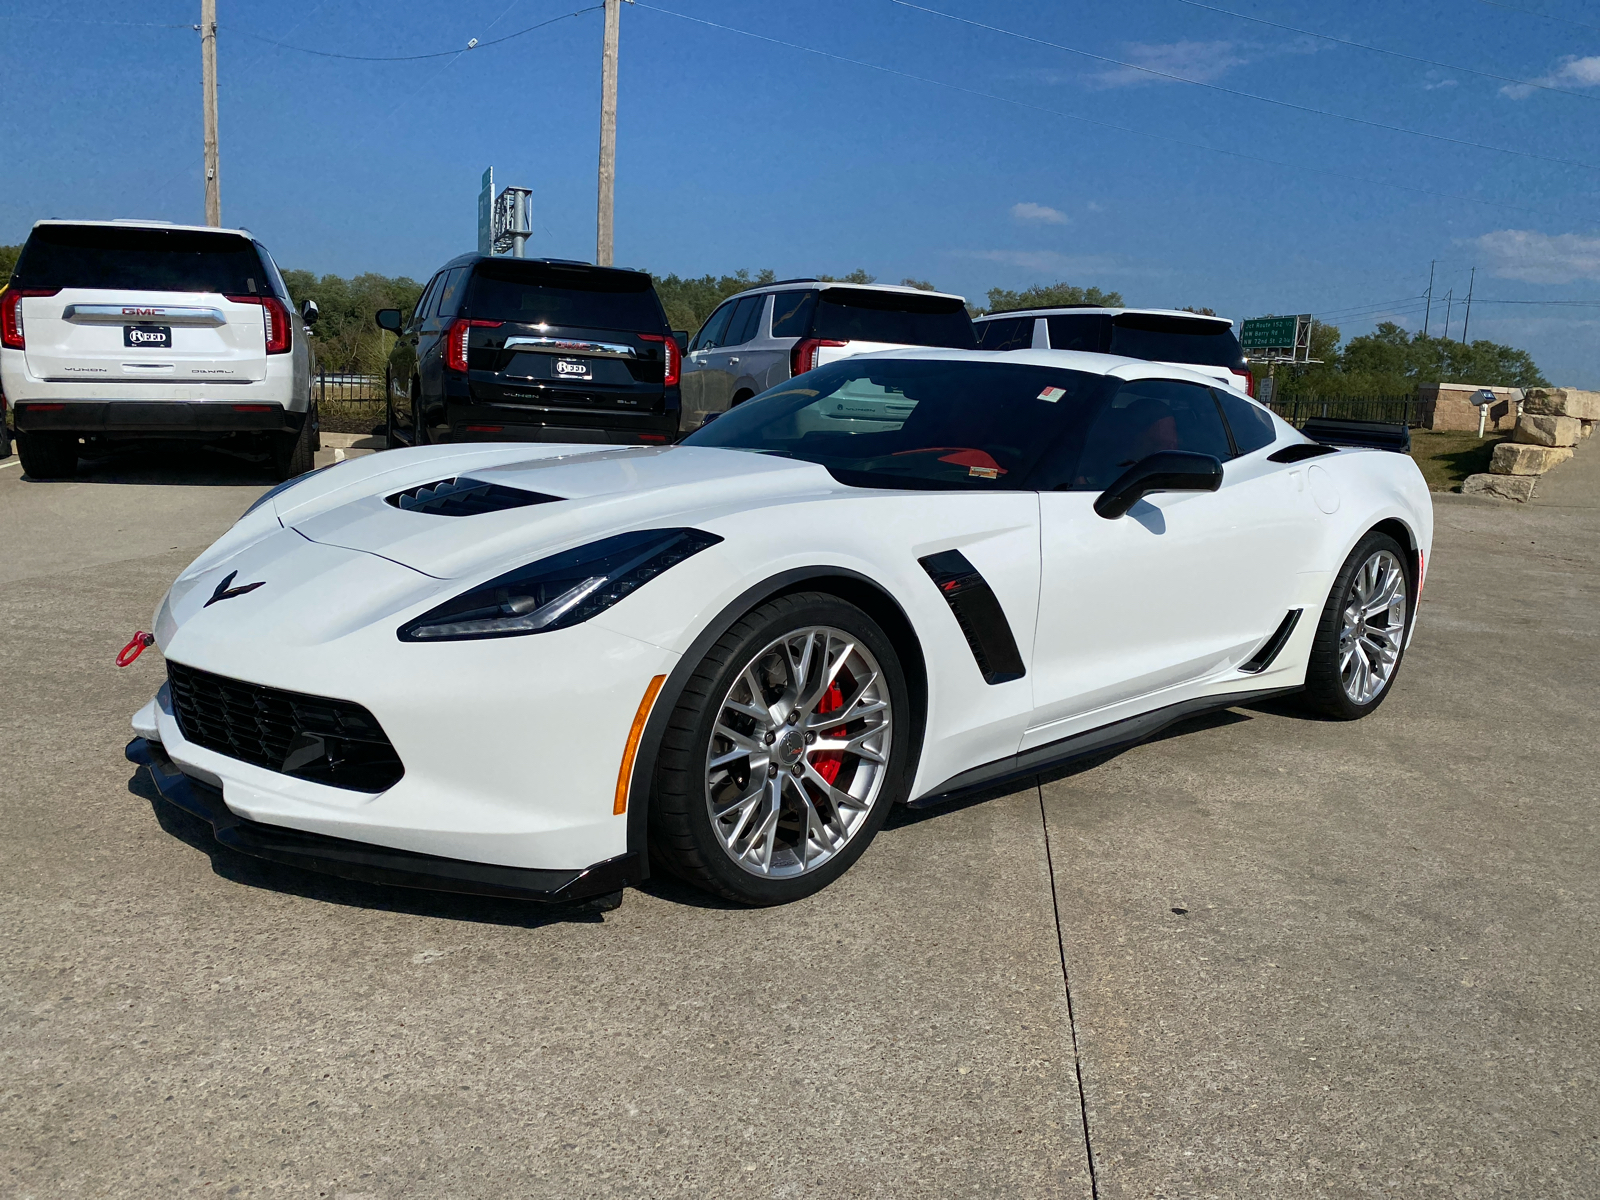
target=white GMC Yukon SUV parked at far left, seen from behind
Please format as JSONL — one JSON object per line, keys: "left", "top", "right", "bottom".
{"left": 0, "top": 221, "right": 318, "bottom": 478}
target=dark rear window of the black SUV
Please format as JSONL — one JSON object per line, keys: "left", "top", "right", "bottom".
{"left": 467, "top": 259, "right": 667, "bottom": 333}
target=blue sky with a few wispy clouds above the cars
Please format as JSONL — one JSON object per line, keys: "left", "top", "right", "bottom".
{"left": 0, "top": 0, "right": 1600, "bottom": 387}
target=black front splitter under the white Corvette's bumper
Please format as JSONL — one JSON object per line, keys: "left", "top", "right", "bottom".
{"left": 126, "top": 738, "right": 640, "bottom": 904}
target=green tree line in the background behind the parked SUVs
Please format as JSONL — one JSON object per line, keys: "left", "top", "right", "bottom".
{"left": 0, "top": 246, "right": 1549, "bottom": 397}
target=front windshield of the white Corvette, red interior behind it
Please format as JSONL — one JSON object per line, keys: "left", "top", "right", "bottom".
{"left": 683, "top": 358, "right": 1106, "bottom": 491}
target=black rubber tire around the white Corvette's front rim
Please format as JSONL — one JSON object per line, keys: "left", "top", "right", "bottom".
{"left": 650, "top": 592, "right": 912, "bottom": 906}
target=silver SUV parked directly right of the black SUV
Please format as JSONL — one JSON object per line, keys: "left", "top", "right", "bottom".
{"left": 680, "top": 278, "right": 974, "bottom": 434}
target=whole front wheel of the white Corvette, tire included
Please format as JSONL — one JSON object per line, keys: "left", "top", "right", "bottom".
{"left": 650, "top": 594, "right": 912, "bottom": 904}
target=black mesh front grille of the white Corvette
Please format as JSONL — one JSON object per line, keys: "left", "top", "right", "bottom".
{"left": 166, "top": 661, "right": 405, "bottom": 792}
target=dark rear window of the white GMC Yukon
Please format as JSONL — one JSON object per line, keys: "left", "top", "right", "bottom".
{"left": 14, "top": 226, "right": 272, "bottom": 296}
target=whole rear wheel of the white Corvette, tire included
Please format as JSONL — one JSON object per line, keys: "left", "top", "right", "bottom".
{"left": 1306, "top": 533, "right": 1414, "bottom": 720}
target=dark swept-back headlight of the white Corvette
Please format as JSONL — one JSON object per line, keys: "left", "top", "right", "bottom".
{"left": 400, "top": 530, "right": 722, "bottom": 642}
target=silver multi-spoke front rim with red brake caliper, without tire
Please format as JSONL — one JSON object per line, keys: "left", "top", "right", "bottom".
{"left": 706, "top": 626, "right": 893, "bottom": 878}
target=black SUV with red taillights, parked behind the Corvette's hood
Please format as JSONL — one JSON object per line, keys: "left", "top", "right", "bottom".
{"left": 378, "top": 254, "right": 682, "bottom": 446}
